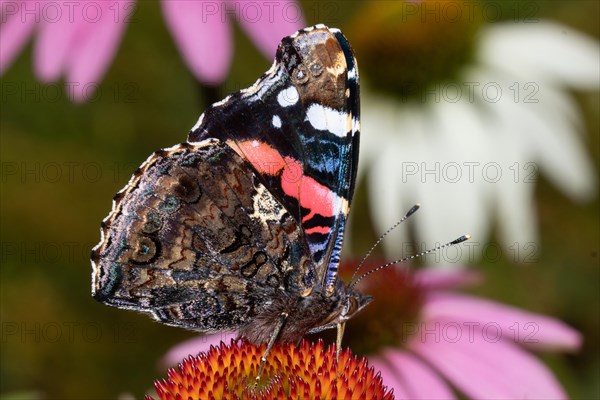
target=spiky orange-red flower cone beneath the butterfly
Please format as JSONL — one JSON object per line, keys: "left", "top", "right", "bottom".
{"left": 148, "top": 341, "right": 393, "bottom": 400}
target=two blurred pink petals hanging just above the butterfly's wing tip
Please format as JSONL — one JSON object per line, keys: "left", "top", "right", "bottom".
{"left": 162, "top": 0, "right": 304, "bottom": 85}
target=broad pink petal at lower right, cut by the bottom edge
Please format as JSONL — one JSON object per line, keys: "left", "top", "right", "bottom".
{"left": 409, "top": 323, "right": 566, "bottom": 399}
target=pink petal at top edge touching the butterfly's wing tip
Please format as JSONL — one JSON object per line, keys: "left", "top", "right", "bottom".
{"left": 229, "top": 0, "right": 305, "bottom": 60}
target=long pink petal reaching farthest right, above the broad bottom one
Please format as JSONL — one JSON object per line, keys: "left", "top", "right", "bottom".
{"left": 421, "top": 292, "right": 582, "bottom": 351}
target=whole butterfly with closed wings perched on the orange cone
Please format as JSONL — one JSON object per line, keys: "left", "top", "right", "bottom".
{"left": 91, "top": 25, "right": 371, "bottom": 368}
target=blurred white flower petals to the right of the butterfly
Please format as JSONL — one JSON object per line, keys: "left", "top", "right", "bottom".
{"left": 360, "top": 22, "right": 600, "bottom": 261}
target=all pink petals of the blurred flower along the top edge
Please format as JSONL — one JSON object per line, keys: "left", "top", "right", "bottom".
{"left": 0, "top": 0, "right": 304, "bottom": 102}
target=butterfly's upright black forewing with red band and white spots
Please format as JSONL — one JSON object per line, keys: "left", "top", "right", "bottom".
{"left": 188, "top": 25, "right": 360, "bottom": 293}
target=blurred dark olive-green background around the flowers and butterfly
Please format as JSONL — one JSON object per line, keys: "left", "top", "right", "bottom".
{"left": 0, "top": 1, "right": 600, "bottom": 398}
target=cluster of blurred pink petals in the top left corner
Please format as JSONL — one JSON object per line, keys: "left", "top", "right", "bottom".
{"left": 0, "top": 0, "right": 135, "bottom": 102}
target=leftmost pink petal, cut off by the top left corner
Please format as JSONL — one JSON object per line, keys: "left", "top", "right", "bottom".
{"left": 0, "top": 1, "right": 37, "bottom": 75}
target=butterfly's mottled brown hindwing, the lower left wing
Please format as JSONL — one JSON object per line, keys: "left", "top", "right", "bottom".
{"left": 92, "top": 140, "right": 316, "bottom": 331}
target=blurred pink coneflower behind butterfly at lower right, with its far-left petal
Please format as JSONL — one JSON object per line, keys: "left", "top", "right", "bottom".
{"left": 164, "top": 269, "right": 581, "bottom": 399}
